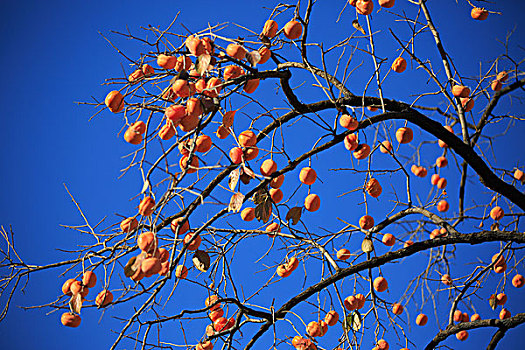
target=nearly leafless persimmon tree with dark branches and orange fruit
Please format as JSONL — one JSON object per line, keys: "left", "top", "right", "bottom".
{"left": 1, "top": 0, "right": 525, "bottom": 350}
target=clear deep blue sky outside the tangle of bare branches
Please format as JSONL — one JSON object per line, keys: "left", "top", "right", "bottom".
{"left": 0, "top": 0, "right": 525, "bottom": 350}
